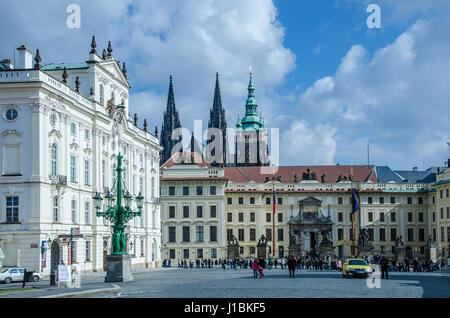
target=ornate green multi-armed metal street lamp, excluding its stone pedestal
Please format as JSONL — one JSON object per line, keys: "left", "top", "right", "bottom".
{"left": 93, "top": 152, "right": 144, "bottom": 255}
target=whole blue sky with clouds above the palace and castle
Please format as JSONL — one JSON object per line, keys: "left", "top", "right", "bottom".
{"left": 0, "top": 0, "right": 450, "bottom": 169}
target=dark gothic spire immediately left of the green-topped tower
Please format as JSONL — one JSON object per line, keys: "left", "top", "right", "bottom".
{"left": 207, "top": 73, "right": 227, "bottom": 166}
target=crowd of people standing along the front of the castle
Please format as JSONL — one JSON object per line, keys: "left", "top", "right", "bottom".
{"left": 162, "top": 255, "right": 446, "bottom": 278}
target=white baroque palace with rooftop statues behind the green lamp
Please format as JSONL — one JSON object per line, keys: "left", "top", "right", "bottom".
{"left": 0, "top": 37, "right": 162, "bottom": 275}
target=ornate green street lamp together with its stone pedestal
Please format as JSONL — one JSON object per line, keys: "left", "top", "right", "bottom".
{"left": 93, "top": 152, "right": 144, "bottom": 282}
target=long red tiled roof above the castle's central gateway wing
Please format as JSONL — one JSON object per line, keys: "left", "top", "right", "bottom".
{"left": 225, "top": 165, "right": 377, "bottom": 183}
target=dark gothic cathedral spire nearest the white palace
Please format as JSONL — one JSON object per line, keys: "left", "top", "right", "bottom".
{"left": 159, "top": 75, "right": 181, "bottom": 165}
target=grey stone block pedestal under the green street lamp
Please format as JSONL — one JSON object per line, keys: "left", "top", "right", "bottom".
{"left": 105, "top": 254, "right": 133, "bottom": 283}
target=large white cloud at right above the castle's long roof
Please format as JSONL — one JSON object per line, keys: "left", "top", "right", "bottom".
{"left": 294, "top": 19, "right": 450, "bottom": 168}
